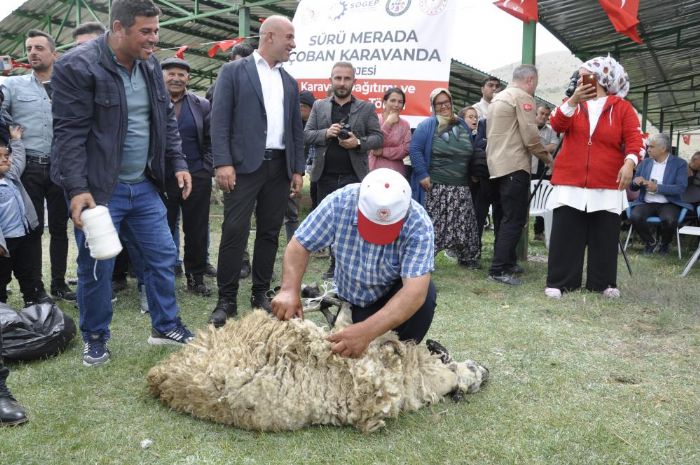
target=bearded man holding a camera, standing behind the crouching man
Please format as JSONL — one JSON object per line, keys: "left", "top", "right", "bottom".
{"left": 304, "top": 61, "right": 384, "bottom": 279}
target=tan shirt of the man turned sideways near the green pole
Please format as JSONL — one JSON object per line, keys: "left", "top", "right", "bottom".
{"left": 486, "top": 86, "right": 550, "bottom": 178}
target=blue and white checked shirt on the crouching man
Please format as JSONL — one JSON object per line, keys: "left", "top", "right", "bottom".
{"left": 294, "top": 184, "right": 435, "bottom": 307}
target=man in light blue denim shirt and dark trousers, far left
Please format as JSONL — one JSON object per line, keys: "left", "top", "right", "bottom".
{"left": 2, "top": 30, "right": 76, "bottom": 304}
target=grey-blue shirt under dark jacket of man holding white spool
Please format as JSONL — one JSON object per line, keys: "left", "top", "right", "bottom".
{"left": 115, "top": 60, "right": 151, "bottom": 184}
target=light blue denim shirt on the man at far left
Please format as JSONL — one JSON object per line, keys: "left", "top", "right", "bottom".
{"left": 2, "top": 72, "right": 53, "bottom": 155}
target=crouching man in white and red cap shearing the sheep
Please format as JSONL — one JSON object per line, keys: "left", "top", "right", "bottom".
{"left": 272, "top": 168, "right": 436, "bottom": 357}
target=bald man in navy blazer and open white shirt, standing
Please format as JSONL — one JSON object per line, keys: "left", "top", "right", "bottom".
{"left": 209, "top": 16, "right": 304, "bottom": 327}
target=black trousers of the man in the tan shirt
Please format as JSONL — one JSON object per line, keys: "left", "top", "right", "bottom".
{"left": 489, "top": 170, "right": 530, "bottom": 275}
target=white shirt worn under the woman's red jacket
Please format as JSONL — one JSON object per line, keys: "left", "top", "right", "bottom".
{"left": 552, "top": 96, "right": 637, "bottom": 215}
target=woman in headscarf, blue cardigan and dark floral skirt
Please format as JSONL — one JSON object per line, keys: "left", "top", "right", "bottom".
{"left": 410, "top": 88, "right": 479, "bottom": 268}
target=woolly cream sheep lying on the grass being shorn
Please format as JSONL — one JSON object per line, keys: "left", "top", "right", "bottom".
{"left": 147, "top": 309, "right": 488, "bottom": 432}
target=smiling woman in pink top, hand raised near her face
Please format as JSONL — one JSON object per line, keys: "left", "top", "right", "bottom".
{"left": 367, "top": 87, "right": 411, "bottom": 176}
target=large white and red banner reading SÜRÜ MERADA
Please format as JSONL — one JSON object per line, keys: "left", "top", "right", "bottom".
{"left": 284, "top": 0, "right": 457, "bottom": 127}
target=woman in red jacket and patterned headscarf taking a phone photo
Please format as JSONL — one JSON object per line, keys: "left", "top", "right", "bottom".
{"left": 545, "top": 55, "right": 642, "bottom": 298}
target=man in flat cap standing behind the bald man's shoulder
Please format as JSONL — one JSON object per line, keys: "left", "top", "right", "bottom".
{"left": 160, "top": 57, "right": 213, "bottom": 296}
